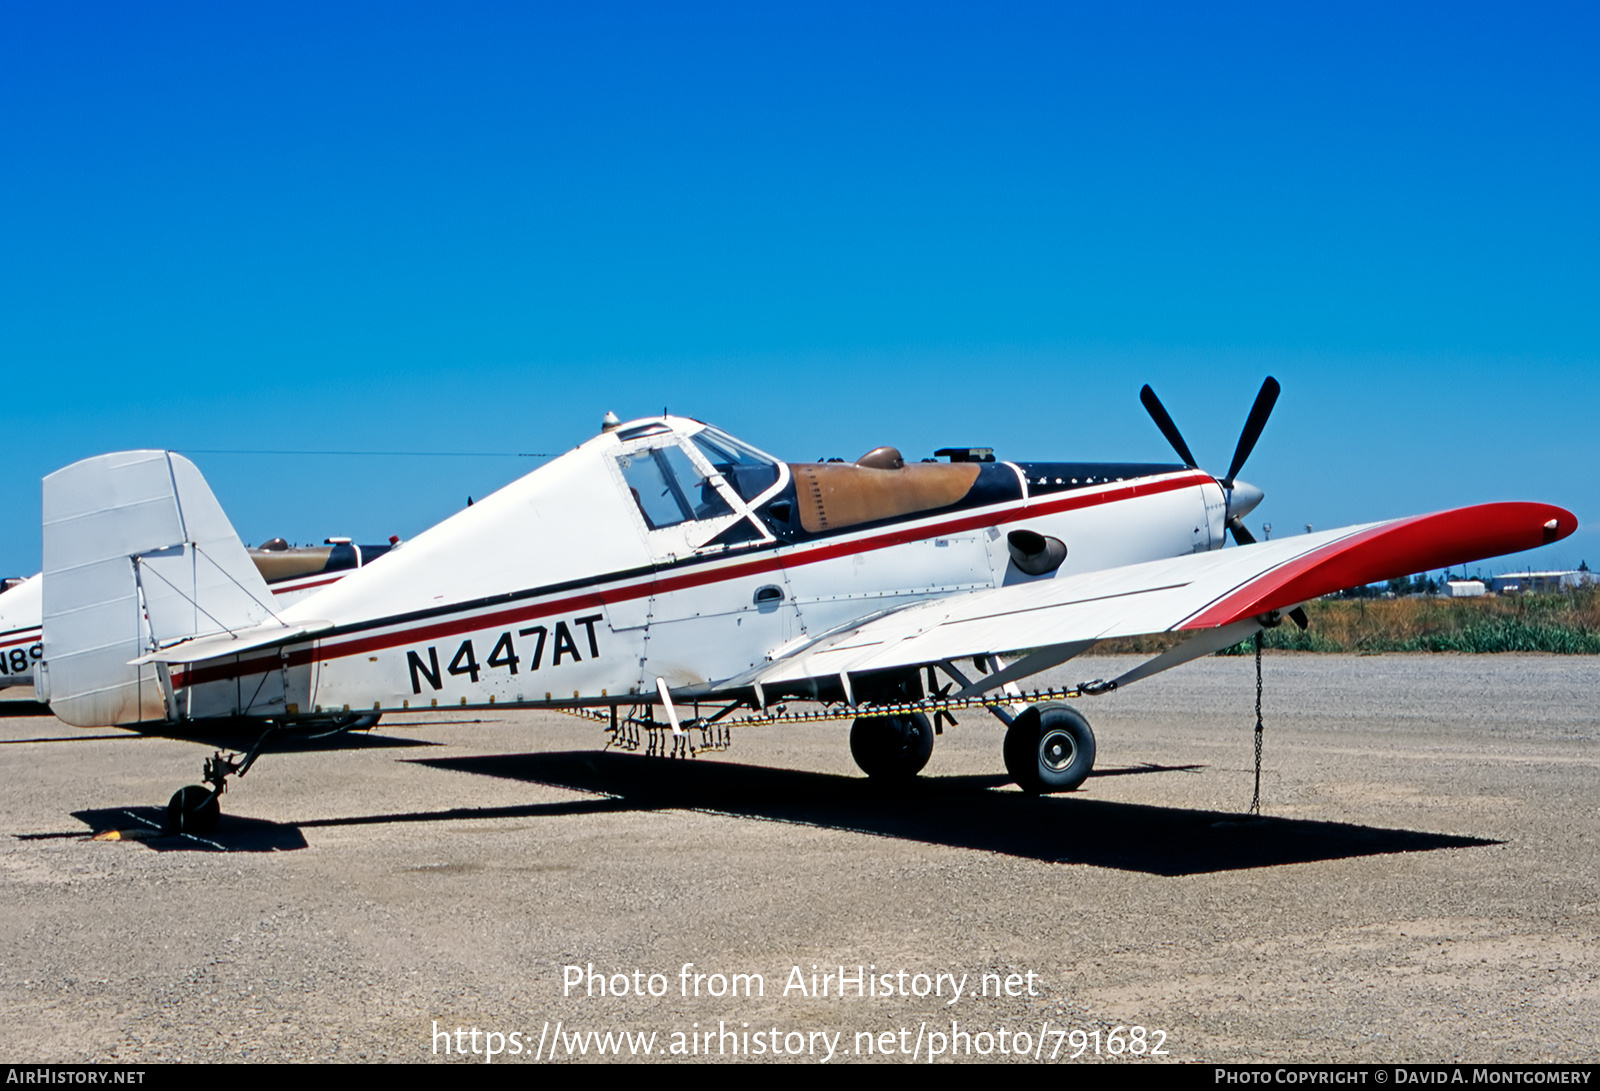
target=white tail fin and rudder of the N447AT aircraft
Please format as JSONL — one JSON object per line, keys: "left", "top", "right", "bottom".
{"left": 35, "top": 451, "right": 274, "bottom": 726}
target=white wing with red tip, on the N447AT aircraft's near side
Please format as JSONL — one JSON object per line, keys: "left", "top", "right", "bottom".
{"left": 728, "top": 504, "right": 1578, "bottom": 696}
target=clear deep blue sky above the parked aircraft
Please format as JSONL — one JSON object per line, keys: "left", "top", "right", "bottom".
{"left": 0, "top": 2, "right": 1600, "bottom": 573}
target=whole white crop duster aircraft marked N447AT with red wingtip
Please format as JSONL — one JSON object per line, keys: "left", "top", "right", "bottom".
{"left": 38, "top": 379, "right": 1576, "bottom": 830}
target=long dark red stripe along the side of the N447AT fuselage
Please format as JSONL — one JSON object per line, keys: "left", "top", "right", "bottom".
{"left": 173, "top": 472, "right": 1214, "bottom": 686}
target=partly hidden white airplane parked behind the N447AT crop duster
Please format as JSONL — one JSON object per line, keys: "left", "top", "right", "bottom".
{"left": 0, "top": 538, "right": 400, "bottom": 701}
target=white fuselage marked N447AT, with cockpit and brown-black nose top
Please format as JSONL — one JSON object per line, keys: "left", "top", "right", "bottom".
{"left": 162, "top": 418, "right": 1224, "bottom": 718}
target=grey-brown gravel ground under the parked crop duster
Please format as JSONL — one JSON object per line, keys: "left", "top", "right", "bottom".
{"left": 0, "top": 656, "right": 1600, "bottom": 1062}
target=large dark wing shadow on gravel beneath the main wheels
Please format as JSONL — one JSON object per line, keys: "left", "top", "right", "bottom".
{"left": 393, "top": 752, "right": 1498, "bottom": 875}
